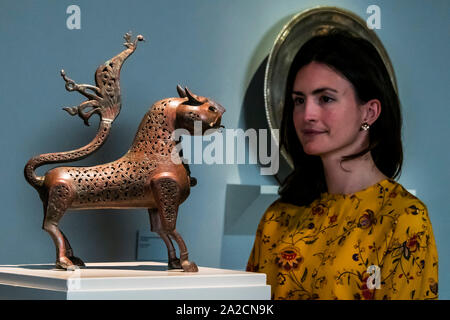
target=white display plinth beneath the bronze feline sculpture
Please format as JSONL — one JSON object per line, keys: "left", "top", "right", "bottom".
{"left": 0, "top": 261, "right": 270, "bottom": 300}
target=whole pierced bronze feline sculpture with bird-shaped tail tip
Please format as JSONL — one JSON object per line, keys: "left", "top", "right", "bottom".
{"left": 24, "top": 34, "right": 225, "bottom": 272}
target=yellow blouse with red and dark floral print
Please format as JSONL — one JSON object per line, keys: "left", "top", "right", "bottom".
{"left": 247, "top": 179, "right": 438, "bottom": 300}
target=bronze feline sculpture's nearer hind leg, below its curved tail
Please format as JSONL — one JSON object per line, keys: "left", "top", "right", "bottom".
{"left": 42, "top": 184, "right": 78, "bottom": 269}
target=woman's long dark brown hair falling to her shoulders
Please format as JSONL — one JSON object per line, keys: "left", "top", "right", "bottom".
{"left": 279, "top": 29, "right": 403, "bottom": 205}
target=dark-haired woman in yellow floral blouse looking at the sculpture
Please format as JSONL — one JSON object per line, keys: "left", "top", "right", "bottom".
{"left": 247, "top": 29, "right": 438, "bottom": 299}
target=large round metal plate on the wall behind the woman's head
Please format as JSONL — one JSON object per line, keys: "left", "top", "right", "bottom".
{"left": 264, "top": 6, "right": 397, "bottom": 168}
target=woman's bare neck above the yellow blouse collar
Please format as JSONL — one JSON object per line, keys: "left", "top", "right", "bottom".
{"left": 321, "top": 152, "right": 388, "bottom": 194}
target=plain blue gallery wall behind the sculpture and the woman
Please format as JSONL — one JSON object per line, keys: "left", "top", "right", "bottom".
{"left": 0, "top": 0, "right": 450, "bottom": 299}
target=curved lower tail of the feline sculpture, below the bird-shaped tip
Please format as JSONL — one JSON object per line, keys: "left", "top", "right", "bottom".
{"left": 24, "top": 120, "right": 112, "bottom": 191}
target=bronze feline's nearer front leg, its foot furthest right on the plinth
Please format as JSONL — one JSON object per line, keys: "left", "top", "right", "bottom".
{"left": 151, "top": 177, "right": 198, "bottom": 272}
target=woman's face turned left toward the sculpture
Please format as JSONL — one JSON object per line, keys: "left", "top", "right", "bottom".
{"left": 292, "top": 61, "right": 368, "bottom": 157}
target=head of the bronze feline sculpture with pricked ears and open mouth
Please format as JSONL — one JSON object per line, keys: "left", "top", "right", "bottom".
{"left": 176, "top": 86, "right": 225, "bottom": 135}
